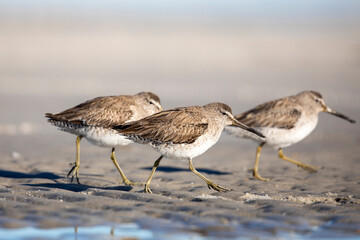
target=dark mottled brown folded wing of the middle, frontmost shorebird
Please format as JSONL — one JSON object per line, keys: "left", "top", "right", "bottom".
{"left": 114, "top": 107, "right": 208, "bottom": 144}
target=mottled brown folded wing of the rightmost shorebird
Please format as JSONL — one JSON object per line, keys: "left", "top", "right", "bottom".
{"left": 235, "top": 98, "right": 301, "bottom": 129}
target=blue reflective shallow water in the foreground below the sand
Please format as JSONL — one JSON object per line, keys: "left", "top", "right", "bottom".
{"left": 0, "top": 217, "right": 360, "bottom": 240}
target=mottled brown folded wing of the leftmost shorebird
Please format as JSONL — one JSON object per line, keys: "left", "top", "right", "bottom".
{"left": 45, "top": 96, "right": 134, "bottom": 127}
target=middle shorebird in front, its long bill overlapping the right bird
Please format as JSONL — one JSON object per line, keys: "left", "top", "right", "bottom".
{"left": 114, "top": 103, "right": 263, "bottom": 193}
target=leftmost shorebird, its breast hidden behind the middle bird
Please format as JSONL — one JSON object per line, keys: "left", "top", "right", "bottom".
{"left": 45, "top": 92, "right": 162, "bottom": 185}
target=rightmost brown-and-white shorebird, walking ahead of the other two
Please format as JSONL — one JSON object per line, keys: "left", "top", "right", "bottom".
{"left": 225, "top": 91, "right": 355, "bottom": 181}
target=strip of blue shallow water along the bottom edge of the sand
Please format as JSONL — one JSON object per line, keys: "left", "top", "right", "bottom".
{"left": 0, "top": 223, "right": 360, "bottom": 240}
